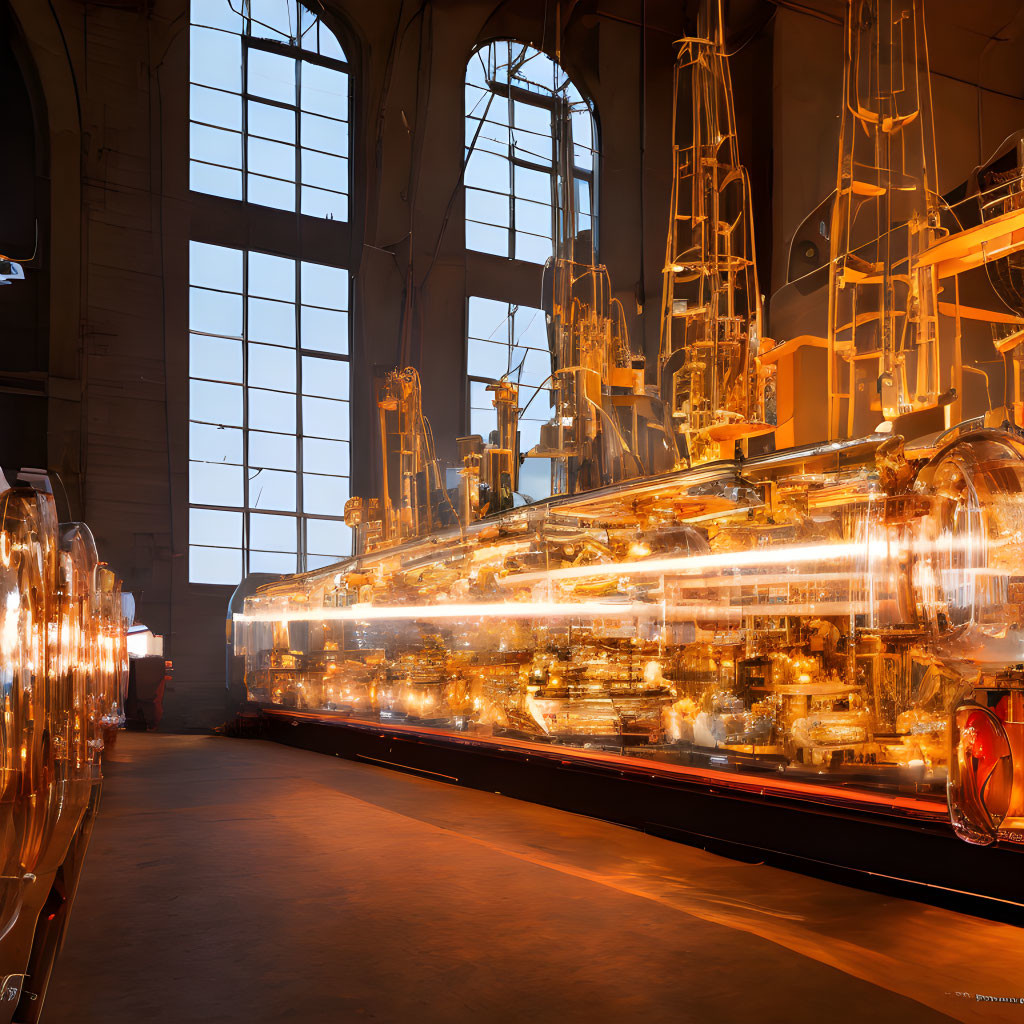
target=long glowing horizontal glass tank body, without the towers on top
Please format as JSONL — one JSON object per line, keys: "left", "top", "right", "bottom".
{"left": 236, "top": 431, "right": 1024, "bottom": 837}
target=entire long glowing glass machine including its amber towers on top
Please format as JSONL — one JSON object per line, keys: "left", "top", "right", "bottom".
{"left": 234, "top": 0, "right": 1024, "bottom": 844}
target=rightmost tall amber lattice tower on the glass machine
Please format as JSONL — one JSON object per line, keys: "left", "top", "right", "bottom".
{"left": 828, "top": 0, "right": 946, "bottom": 438}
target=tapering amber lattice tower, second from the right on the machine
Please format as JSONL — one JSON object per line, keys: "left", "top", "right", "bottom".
{"left": 657, "top": 0, "right": 773, "bottom": 464}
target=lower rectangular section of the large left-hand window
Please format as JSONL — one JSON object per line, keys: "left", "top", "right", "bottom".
{"left": 188, "top": 242, "right": 350, "bottom": 583}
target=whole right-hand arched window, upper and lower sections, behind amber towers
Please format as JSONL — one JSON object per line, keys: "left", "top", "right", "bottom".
{"left": 465, "top": 40, "right": 598, "bottom": 499}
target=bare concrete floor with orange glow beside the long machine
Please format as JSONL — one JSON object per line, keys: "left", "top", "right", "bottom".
{"left": 43, "top": 733, "right": 1024, "bottom": 1024}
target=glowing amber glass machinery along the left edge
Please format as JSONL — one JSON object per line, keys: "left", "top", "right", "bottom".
{"left": 0, "top": 476, "right": 128, "bottom": 1021}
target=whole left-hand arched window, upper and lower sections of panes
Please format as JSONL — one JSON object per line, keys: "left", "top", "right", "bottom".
{"left": 188, "top": 0, "right": 350, "bottom": 585}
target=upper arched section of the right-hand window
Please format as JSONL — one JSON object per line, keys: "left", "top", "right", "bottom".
{"left": 465, "top": 40, "right": 597, "bottom": 263}
